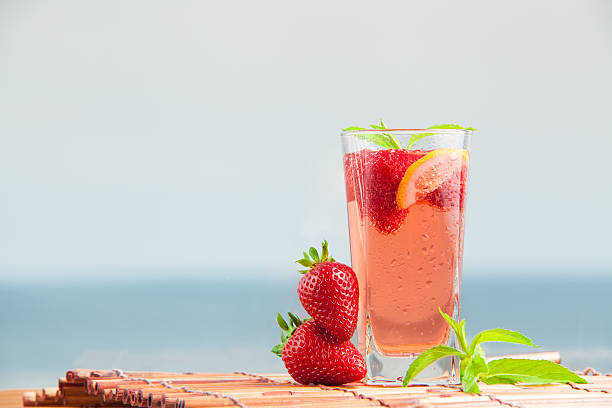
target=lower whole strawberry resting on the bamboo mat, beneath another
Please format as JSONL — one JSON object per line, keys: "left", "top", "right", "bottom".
{"left": 272, "top": 314, "right": 366, "bottom": 385}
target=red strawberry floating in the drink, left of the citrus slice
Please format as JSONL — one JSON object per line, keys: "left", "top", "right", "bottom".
{"left": 344, "top": 149, "right": 427, "bottom": 234}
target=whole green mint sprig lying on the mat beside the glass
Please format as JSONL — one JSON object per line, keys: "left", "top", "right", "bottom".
{"left": 403, "top": 310, "right": 587, "bottom": 393}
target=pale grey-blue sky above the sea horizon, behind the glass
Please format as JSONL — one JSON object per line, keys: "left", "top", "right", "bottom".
{"left": 0, "top": 1, "right": 612, "bottom": 279}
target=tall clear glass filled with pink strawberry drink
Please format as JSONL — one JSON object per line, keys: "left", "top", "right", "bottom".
{"left": 341, "top": 129, "right": 472, "bottom": 384}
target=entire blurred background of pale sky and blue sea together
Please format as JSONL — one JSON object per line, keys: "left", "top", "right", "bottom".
{"left": 0, "top": 0, "right": 612, "bottom": 388}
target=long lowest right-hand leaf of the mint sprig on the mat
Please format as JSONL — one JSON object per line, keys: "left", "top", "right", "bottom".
{"left": 483, "top": 358, "right": 587, "bottom": 384}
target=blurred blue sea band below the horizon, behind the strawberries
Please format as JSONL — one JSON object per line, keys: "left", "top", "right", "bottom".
{"left": 0, "top": 270, "right": 612, "bottom": 388}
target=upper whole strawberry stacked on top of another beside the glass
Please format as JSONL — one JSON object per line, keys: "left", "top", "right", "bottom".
{"left": 297, "top": 241, "right": 359, "bottom": 341}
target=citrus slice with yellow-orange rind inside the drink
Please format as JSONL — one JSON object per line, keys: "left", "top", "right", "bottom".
{"left": 395, "top": 149, "right": 469, "bottom": 210}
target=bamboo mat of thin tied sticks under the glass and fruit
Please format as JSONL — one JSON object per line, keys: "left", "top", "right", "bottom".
{"left": 23, "top": 369, "right": 612, "bottom": 408}
